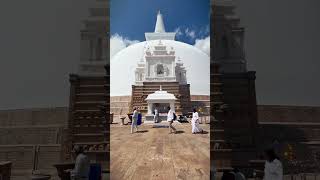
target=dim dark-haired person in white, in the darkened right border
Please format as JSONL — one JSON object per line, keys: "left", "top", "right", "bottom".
{"left": 263, "top": 149, "right": 283, "bottom": 180}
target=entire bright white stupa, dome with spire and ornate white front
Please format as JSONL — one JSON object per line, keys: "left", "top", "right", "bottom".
{"left": 110, "top": 11, "right": 210, "bottom": 96}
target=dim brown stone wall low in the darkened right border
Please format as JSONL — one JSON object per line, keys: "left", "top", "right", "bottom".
{"left": 257, "top": 105, "right": 320, "bottom": 172}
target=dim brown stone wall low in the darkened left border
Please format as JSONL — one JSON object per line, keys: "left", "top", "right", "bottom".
{"left": 0, "top": 107, "right": 68, "bottom": 179}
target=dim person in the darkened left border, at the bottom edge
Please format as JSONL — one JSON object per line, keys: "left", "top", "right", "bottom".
{"left": 70, "top": 145, "right": 90, "bottom": 180}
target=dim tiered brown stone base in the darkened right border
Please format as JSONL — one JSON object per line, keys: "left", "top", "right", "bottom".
{"left": 210, "top": 63, "right": 262, "bottom": 175}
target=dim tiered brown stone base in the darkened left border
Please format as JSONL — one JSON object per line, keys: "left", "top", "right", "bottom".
{"left": 66, "top": 75, "right": 110, "bottom": 171}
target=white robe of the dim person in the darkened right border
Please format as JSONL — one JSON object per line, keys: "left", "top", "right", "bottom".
{"left": 263, "top": 159, "right": 283, "bottom": 180}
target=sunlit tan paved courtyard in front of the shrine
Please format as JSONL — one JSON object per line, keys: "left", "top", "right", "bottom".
{"left": 110, "top": 123, "right": 210, "bottom": 180}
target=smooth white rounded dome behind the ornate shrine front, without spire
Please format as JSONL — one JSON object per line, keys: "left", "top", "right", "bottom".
{"left": 110, "top": 40, "right": 210, "bottom": 96}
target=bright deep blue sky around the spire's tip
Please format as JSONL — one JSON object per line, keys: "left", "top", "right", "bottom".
{"left": 110, "top": 0, "right": 210, "bottom": 44}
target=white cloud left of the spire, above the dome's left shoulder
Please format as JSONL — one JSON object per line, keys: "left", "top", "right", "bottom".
{"left": 110, "top": 34, "right": 139, "bottom": 58}
